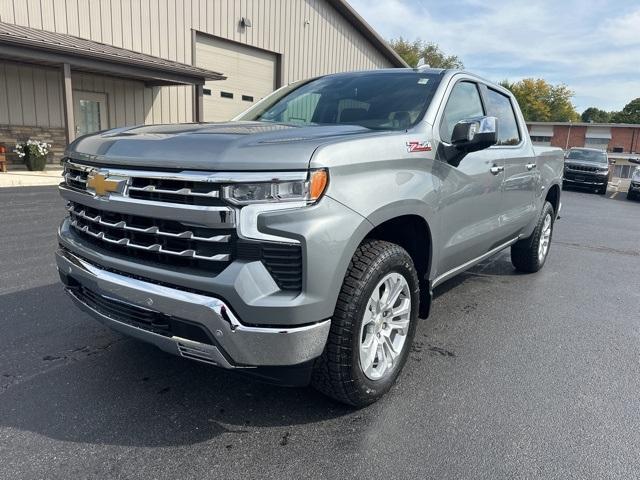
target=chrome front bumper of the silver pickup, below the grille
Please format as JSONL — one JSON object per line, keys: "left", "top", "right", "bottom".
{"left": 56, "top": 249, "right": 331, "bottom": 369}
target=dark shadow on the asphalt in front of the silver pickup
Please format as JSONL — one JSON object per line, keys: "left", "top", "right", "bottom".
{"left": 0, "top": 284, "right": 353, "bottom": 447}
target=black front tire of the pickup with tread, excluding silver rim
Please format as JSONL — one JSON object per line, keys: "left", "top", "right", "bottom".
{"left": 311, "top": 240, "right": 420, "bottom": 407}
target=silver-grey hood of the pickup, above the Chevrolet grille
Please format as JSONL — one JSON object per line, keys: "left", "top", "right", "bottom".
{"left": 67, "top": 122, "right": 380, "bottom": 171}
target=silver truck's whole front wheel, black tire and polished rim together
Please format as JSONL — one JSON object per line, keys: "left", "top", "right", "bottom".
{"left": 312, "top": 240, "right": 419, "bottom": 407}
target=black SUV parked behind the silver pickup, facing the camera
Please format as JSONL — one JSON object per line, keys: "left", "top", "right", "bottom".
{"left": 562, "top": 148, "right": 609, "bottom": 195}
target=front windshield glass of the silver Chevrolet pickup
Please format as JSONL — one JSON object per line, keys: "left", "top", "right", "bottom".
{"left": 238, "top": 71, "right": 441, "bottom": 130}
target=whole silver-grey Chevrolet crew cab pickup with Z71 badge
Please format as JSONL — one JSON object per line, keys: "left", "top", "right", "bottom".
{"left": 56, "top": 69, "right": 563, "bottom": 407}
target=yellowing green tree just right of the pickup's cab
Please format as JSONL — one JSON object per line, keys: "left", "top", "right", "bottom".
{"left": 500, "top": 78, "right": 580, "bottom": 122}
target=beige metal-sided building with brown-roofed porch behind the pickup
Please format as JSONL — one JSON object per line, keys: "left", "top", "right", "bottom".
{"left": 0, "top": 0, "right": 406, "bottom": 165}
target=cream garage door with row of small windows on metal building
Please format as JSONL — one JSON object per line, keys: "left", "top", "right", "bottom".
{"left": 196, "top": 35, "right": 276, "bottom": 122}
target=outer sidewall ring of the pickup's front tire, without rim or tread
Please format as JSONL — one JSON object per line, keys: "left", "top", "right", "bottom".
{"left": 351, "top": 252, "right": 419, "bottom": 401}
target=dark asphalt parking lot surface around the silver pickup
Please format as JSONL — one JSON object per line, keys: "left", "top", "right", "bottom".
{"left": 0, "top": 187, "right": 640, "bottom": 479}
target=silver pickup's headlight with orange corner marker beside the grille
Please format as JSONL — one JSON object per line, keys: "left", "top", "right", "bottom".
{"left": 222, "top": 169, "right": 329, "bottom": 205}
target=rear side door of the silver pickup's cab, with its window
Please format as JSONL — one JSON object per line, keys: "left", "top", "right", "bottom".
{"left": 481, "top": 85, "right": 538, "bottom": 238}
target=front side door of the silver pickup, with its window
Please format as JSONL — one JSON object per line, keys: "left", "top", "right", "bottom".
{"left": 434, "top": 80, "right": 504, "bottom": 283}
